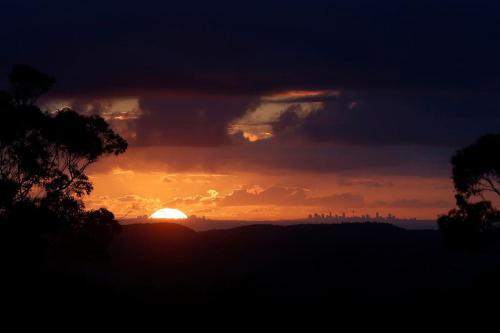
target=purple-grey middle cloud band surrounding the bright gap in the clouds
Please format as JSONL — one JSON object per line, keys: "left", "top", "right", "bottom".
{"left": 63, "top": 92, "right": 500, "bottom": 148}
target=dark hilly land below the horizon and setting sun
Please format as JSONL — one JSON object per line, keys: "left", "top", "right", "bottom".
{"left": 5, "top": 223, "right": 500, "bottom": 315}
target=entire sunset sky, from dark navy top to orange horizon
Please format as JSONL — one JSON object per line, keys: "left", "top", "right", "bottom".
{"left": 0, "top": 0, "right": 500, "bottom": 219}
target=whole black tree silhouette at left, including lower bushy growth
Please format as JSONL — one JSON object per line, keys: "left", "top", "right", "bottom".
{"left": 0, "top": 65, "right": 127, "bottom": 268}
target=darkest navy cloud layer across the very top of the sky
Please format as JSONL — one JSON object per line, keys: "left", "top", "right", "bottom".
{"left": 0, "top": 0, "right": 500, "bottom": 95}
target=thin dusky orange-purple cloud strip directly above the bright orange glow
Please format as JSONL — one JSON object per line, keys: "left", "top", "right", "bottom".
{"left": 87, "top": 142, "right": 453, "bottom": 177}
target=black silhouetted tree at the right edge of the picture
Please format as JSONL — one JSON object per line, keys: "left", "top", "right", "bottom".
{"left": 437, "top": 134, "right": 500, "bottom": 248}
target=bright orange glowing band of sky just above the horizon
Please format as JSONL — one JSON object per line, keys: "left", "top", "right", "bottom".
{"left": 85, "top": 158, "right": 453, "bottom": 223}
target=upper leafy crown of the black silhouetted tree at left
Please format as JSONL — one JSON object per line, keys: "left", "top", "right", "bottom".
{"left": 0, "top": 65, "right": 127, "bottom": 209}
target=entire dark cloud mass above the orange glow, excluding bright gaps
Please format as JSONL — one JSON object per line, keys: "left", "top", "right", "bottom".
{"left": 0, "top": 0, "right": 500, "bottom": 175}
